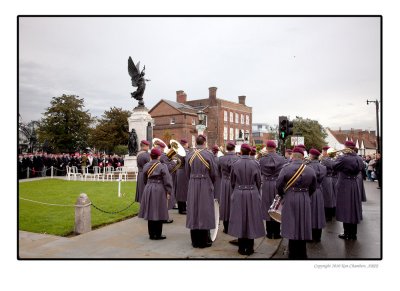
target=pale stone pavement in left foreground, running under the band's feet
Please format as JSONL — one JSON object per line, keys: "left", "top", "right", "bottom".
{"left": 18, "top": 210, "right": 282, "bottom": 259}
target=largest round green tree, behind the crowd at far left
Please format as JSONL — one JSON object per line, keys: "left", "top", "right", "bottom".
{"left": 38, "top": 94, "right": 92, "bottom": 152}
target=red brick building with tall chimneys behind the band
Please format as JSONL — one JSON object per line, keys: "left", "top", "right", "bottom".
{"left": 149, "top": 87, "right": 252, "bottom": 146}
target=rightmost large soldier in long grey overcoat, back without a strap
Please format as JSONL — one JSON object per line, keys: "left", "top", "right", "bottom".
{"left": 333, "top": 141, "right": 364, "bottom": 240}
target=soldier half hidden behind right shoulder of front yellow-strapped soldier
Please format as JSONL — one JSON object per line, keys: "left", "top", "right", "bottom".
{"left": 308, "top": 149, "right": 326, "bottom": 242}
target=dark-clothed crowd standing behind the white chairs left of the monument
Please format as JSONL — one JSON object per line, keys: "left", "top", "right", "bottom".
{"left": 17, "top": 152, "right": 124, "bottom": 179}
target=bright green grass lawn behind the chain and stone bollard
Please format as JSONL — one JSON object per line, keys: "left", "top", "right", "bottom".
{"left": 18, "top": 179, "right": 139, "bottom": 236}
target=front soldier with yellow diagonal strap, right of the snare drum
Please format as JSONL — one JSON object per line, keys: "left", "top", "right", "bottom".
{"left": 276, "top": 147, "right": 317, "bottom": 259}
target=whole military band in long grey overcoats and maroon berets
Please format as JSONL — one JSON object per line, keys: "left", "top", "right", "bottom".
{"left": 136, "top": 135, "right": 381, "bottom": 259}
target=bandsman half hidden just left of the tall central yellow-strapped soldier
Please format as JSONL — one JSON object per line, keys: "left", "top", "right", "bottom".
{"left": 175, "top": 138, "right": 189, "bottom": 214}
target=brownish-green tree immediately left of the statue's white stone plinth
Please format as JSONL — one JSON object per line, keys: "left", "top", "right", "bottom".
{"left": 90, "top": 107, "right": 130, "bottom": 152}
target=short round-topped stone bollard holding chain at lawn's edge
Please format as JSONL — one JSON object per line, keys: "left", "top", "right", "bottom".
{"left": 75, "top": 193, "right": 92, "bottom": 234}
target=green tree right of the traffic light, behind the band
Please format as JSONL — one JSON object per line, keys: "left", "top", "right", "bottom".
{"left": 286, "top": 116, "right": 327, "bottom": 150}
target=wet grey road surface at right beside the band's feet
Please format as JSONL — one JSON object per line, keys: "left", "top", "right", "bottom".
{"left": 273, "top": 181, "right": 382, "bottom": 259}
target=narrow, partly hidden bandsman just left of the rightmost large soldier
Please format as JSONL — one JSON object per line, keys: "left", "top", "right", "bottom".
{"left": 321, "top": 146, "right": 336, "bottom": 221}
